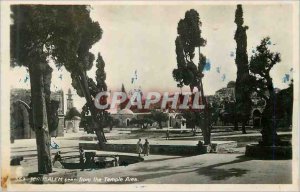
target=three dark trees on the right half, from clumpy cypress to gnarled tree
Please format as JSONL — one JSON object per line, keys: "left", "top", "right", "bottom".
{"left": 173, "top": 5, "right": 293, "bottom": 145}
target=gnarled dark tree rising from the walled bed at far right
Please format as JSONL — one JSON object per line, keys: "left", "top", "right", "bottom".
{"left": 249, "top": 37, "right": 293, "bottom": 146}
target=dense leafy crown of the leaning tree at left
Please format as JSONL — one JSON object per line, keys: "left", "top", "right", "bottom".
{"left": 48, "top": 5, "right": 102, "bottom": 74}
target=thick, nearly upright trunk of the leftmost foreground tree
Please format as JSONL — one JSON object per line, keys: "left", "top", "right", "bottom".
{"left": 29, "top": 63, "right": 52, "bottom": 174}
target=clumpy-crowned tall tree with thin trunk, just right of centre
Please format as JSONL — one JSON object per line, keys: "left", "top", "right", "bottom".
{"left": 172, "top": 9, "right": 210, "bottom": 144}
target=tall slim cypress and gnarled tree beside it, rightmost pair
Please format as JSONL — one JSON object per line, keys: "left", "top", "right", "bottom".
{"left": 234, "top": 5, "right": 293, "bottom": 146}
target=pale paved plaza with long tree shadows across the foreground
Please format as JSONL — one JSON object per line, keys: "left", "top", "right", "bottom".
{"left": 11, "top": 131, "right": 292, "bottom": 184}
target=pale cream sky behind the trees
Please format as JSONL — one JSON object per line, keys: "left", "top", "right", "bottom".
{"left": 10, "top": 4, "right": 293, "bottom": 110}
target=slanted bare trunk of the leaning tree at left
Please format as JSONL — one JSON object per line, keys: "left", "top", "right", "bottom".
{"left": 78, "top": 72, "right": 107, "bottom": 146}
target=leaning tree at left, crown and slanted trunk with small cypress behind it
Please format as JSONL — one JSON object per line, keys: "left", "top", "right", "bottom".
{"left": 48, "top": 5, "right": 108, "bottom": 144}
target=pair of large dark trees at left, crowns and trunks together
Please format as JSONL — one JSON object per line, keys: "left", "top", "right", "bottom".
{"left": 10, "top": 5, "right": 108, "bottom": 173}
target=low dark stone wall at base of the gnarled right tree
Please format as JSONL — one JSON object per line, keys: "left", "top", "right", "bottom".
{"left": 245, "top": 144, "right": 293, "bottom": 160}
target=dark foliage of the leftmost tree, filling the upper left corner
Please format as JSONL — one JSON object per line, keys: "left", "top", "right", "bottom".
{"left": 10, "top": 5, "right": 53, "bottom": 67}
